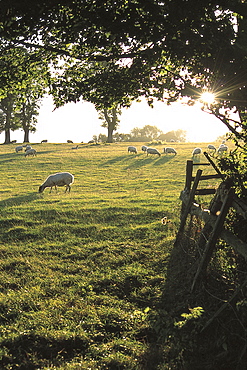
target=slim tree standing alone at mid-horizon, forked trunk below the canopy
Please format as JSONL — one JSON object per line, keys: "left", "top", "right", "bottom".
{"left": 98, "top": 106, "right": 121, "bottom": 143}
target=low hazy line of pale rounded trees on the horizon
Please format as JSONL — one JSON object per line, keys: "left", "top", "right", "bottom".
{"left": 93, "top": 125, "right": 187, "bottom": 143}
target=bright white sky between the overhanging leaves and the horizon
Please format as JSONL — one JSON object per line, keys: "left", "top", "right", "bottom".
{"left": 0, "top": 97, "right": 227, "bottom": 143}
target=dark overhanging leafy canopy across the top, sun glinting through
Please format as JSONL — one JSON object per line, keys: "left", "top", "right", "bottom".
{"left": 0, "top": 0, "right": 247, "bottom": 145}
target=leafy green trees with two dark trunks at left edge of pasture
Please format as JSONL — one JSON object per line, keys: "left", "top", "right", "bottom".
{"left": 0, "top": 47, "right": 49, "bottom": 144}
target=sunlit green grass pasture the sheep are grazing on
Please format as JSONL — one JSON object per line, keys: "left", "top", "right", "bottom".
{"left": 0, "top": 143, "right": 236, "bottom": 370}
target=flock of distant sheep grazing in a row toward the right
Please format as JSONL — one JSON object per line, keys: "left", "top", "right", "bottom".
{"left": 128, "top": 143, "right": 228, "bottom": 158}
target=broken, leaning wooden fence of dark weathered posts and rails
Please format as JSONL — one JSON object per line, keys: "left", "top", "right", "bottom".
{"left": 174, "top": 152, "right": 247, "bottom": 291}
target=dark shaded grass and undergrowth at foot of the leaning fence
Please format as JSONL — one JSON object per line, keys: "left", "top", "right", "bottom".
{"left": 143, "top": 228, "right": 246, "bottom": 370}
